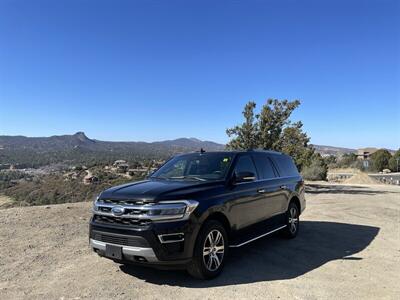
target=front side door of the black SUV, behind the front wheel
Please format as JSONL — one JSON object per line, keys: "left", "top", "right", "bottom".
{"left": 229, "top": 154, "right": 264, "bottom": 229}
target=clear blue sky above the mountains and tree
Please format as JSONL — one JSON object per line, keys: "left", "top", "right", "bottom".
{"left": 0, "top": 0, "right": 400, "bottom": 148}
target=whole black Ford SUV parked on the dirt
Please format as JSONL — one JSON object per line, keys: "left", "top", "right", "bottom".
{"left": 90, "top": 151, "right": 306, "bottom": 278}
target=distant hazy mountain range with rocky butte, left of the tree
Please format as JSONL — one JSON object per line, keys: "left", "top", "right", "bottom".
{"left": 0, "top": 132, "right": 225, "bottom": 167}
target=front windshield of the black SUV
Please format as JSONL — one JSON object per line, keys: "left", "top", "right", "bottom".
{"left": 151, "top": 152, "right": 233, "bottom": 181}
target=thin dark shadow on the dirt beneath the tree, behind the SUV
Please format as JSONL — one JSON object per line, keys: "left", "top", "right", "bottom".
{"left": 306, "top": 184, "right": 390, "bottom": 195}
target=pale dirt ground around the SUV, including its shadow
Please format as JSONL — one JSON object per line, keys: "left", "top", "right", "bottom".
{"left": 0, "top": 183, "right": 400, "bottom": 300}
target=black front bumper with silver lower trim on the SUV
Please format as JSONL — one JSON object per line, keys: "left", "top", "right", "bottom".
{"left": 89, "top": 219, "right": 200, "bottom": 267}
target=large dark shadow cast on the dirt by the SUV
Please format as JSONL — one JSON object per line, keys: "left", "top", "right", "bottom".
{"left": 120, "top": 221, "right": 379, "bottom": 288}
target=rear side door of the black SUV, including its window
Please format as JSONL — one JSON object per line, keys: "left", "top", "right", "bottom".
{"left": 252, "top": 152, "right": 286, "bottom": 219}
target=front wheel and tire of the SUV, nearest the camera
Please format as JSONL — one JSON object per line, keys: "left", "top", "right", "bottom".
{"left": 187, "top": 220, "right": 228, "bottom": 279}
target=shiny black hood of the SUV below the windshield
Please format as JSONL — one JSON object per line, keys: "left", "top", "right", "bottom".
{"left": 100, "top": 179, "right": 223, "bottom": 202}
